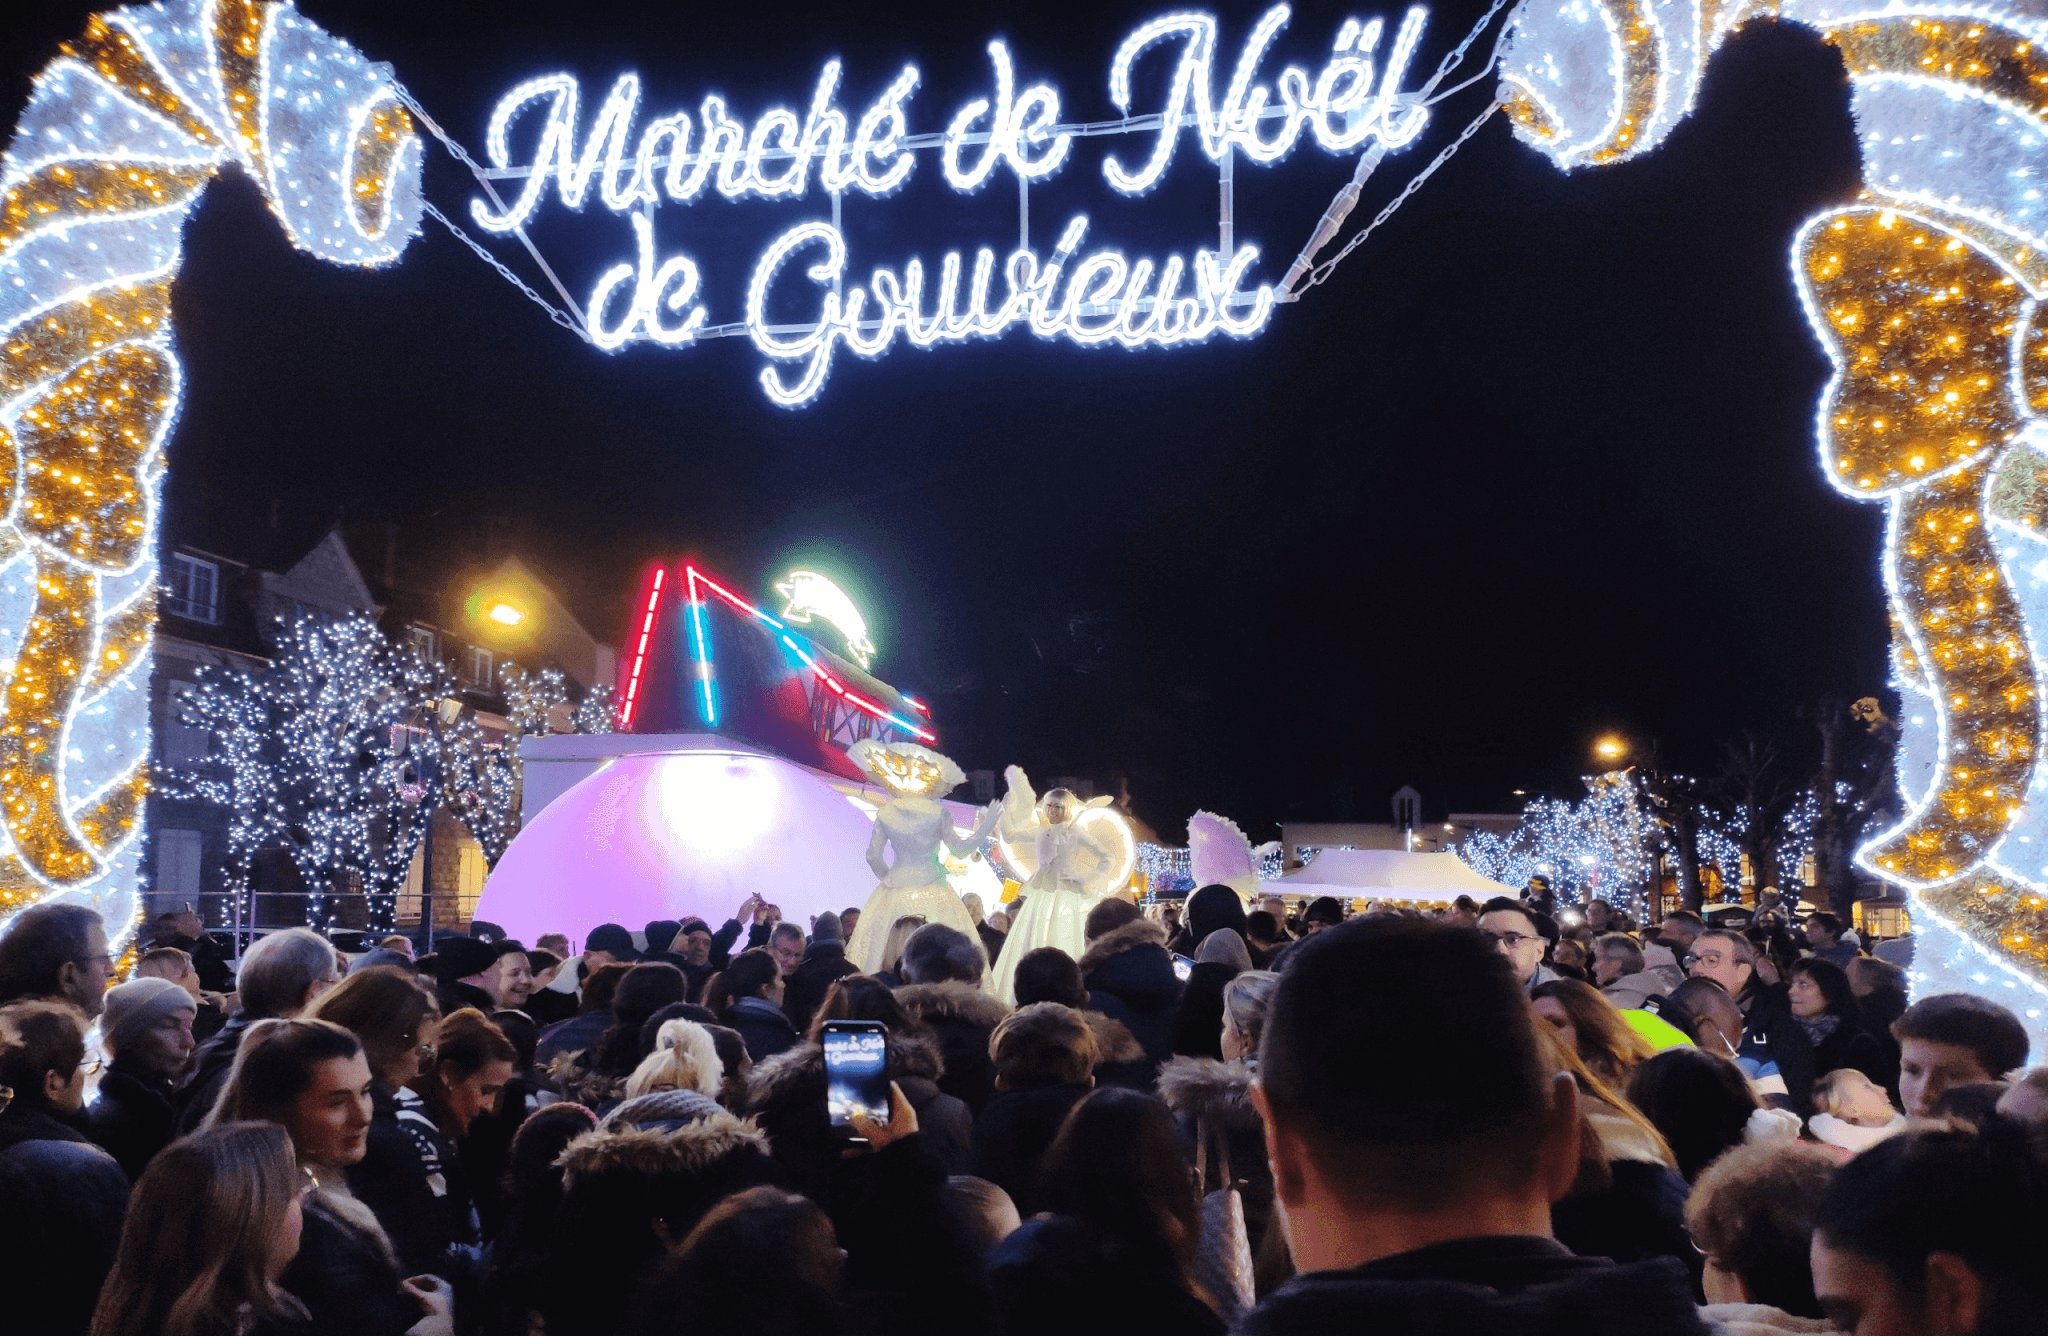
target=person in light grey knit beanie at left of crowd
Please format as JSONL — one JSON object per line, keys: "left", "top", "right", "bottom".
{"left": 86, "top": 979, "right": 199, "bottom": 1182}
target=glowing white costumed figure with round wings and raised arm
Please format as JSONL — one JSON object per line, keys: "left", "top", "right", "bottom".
{"left": 991, "top": 766, "right": 1137, "bottom": 1002}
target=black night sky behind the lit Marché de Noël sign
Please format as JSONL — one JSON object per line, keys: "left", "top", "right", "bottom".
{"left": 0, "top": 0, "right": 1884, "bottom": 836}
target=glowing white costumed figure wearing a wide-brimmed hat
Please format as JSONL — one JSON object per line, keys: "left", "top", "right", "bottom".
{"left": 846, "top": 738, "right": 1001, "bottom": 973}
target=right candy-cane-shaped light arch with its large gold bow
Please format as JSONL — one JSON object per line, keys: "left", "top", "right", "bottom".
{"left": 1499, "top": 0, "right": 2048, "bottom": 1043}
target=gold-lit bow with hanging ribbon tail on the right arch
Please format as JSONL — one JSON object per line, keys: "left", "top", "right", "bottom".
{"left": 1796, "top": 205, "right": 2048, "bottom": 969}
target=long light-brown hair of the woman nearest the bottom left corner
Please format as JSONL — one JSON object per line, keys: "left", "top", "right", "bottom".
{"left": 90, "top": 1123, "right": 303, "bottom": 1336}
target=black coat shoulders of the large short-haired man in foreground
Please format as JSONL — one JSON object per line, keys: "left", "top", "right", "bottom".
{"left": 1237, "top": 1236, "right": 1710, "bottom": 1336}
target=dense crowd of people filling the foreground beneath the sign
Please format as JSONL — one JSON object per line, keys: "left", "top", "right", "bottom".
{"left": 0, "top": 885, "right": 2048, "bottom": 1336}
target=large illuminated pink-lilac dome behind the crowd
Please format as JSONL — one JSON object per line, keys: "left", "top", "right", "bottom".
{"left": 475, "top": 748, "right": 874, "bottom": 947}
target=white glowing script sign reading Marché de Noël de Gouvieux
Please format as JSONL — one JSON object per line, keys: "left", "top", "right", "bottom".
{"left": 469, "top": 4, "right": 1430, "bottom": 408}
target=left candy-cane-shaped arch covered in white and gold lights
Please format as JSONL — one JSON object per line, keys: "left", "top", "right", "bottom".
{"left": 0, "top": 0, "right": 422, "bottom": 943}
